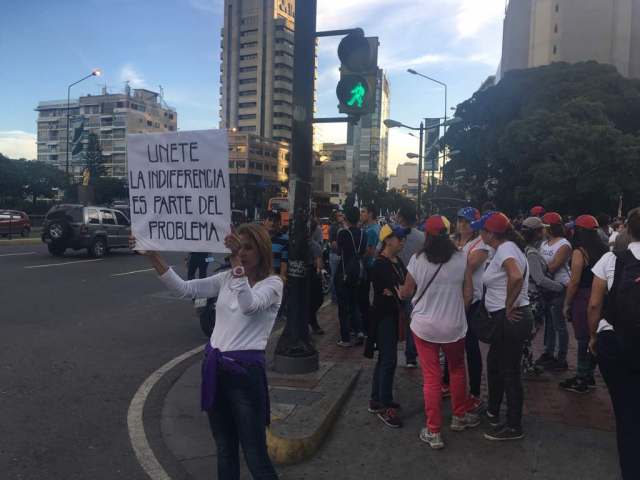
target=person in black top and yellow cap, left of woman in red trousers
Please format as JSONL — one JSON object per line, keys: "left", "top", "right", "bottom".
{"left": 365, "top": 225, "right": 408, "bottom": 428}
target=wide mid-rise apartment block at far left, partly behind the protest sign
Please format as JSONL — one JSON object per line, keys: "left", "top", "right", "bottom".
{"left": 36, "top": 85, "right": 178, "bottom": 178}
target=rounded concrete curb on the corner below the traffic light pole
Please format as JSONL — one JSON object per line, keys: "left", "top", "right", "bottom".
{"left": 267, "top": 364, "right": 362, "bottom": 465}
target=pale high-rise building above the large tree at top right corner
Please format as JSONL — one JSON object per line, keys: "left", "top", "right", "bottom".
{"left": 500, "top": 0, "right": 640, "bottom": 78}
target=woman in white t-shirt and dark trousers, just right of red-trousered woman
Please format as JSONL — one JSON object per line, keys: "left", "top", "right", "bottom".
{"left": 475, "top": 212, "right": 533, "bottom": 441}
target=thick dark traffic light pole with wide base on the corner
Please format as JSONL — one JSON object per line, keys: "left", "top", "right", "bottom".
{"left": 274, "top": 0, "right": 319, "bottom": 373}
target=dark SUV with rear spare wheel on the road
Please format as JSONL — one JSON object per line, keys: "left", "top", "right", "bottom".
{"left": 42, "top": 204, "right": 131, "bottom": 258}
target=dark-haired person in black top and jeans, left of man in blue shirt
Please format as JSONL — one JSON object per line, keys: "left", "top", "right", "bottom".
{"left": 334, "top": 207, "right": 367, "bottom": 347}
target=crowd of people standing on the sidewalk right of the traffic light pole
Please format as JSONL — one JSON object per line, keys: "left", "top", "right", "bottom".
{"left": 330, "top": 201, "right": 640, "bottom": 479}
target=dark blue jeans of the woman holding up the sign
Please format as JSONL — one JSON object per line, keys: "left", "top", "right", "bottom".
{"left": 208, "top": 366, "right": 278, "bottom": 480}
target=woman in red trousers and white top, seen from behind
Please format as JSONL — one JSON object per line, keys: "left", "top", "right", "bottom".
{"left": 400, "top": 215, "right": 481, "bottom": 449}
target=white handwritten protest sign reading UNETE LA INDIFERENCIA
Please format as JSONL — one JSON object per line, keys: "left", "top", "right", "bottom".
{"left": 127, "top": 130, "right": 231, "bottom": 253}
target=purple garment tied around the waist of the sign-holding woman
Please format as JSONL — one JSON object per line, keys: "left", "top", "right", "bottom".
{"left": 200, "top": 342, "right": 271, "bottom": 425}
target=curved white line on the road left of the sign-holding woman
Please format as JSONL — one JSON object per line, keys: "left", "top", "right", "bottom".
{"left": 127, "top": 345, "right": 202, "bottom": 480}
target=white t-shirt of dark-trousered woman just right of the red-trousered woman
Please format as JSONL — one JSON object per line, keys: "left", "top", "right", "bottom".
{"left": 482, "top": 242, "right": 529, "bottom": 312}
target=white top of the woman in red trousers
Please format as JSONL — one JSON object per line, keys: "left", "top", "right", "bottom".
{"left": 407, "top": 251, "right": 467, "bottom": 343}
